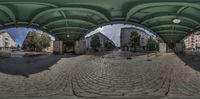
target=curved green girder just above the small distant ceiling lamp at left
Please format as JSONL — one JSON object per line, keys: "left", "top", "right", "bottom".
{"left": 48, "top": 27, "right": 88, "bottom": 32}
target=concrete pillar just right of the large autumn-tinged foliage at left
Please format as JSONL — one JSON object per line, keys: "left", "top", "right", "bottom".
{"left": 53, "top": 41, "right": 64, "bottom": 54}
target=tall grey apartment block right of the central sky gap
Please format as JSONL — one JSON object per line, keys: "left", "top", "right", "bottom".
{"left": 120, "top": 28, "right": 156, "bottom": 50}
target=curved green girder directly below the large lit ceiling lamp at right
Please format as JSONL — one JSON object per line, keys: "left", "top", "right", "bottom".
{"left": 150, "top": 24, "right": 193, "bottom": 30}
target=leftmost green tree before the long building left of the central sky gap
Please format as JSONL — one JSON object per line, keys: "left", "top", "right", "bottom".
{"left": 90, "top": 35, "right": 101, "bottom": 51}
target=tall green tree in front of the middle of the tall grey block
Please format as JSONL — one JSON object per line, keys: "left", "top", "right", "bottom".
{"left": 129, "top": 31, "right": 140, "bottom": 51}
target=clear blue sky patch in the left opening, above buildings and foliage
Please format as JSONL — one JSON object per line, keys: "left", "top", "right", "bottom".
{"left": 0, "top": 27, "right": 54, "bottom": 46}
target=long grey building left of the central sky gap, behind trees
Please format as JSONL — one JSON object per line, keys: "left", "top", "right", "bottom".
{"left": 85, "top": 32, "right": 115, "bottom": 51}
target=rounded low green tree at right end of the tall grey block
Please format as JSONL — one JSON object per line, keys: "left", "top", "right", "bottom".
{"left": 147, "top": 37, "right": 158, "bottom": 50}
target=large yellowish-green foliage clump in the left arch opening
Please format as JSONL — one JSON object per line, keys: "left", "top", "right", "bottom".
{"left": 23, "top": 31, "right": 51, "bottom": 51}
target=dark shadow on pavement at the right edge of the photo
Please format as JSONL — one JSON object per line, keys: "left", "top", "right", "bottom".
{"left": 177, "top": 54, "right": 200, "bottom": 72}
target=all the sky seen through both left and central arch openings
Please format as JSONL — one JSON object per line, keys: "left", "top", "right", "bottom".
{"left": 0, "top": 24, "right": 153, "bottom": 46}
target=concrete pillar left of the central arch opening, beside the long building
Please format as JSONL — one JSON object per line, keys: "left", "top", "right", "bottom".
{"left": 74, "top": 40, "right": 86, "bottom": 54}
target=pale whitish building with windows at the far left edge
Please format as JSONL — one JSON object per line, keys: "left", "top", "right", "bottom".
{"left": 0, "top": 32, "right": 17, "bottom": 50}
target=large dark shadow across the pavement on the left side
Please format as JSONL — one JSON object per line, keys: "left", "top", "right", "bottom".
{"left": 0, "top": 55, "right": 77, "bottom": 77}
